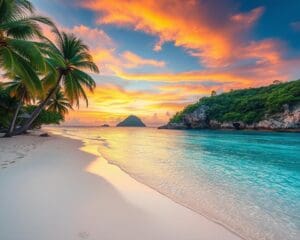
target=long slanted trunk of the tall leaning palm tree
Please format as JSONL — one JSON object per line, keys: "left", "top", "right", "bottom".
{"left": 13, "top": 72, "right": 63, "bottom": 135}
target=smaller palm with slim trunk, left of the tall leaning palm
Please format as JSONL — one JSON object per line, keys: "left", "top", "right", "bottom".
{"left": 2, "top": 77, "right": 33, "bottom": 137}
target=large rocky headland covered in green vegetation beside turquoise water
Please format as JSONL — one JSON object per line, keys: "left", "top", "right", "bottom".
{"left": 160, "top": 80, "right": 300, "bottom": 131}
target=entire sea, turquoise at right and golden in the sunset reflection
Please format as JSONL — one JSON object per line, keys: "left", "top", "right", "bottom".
{"left": 51, "top": 128, "right": 300, "bottom": 240}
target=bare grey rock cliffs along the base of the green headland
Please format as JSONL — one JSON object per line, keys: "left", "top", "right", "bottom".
{"left": 160, "top": 105, "right": 300, "bottom": 131}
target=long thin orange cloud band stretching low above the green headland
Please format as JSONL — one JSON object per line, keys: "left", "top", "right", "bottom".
{"left": 113, "top": 50, "right": 300, "bottom": 88}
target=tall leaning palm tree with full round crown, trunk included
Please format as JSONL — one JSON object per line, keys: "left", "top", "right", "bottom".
{"left": 16, "top": 29, "right": 99, "bottom": 134}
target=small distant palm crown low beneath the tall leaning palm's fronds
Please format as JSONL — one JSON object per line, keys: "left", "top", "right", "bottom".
{"left": 47, "top": 89, "right": 72, "bottom": 116}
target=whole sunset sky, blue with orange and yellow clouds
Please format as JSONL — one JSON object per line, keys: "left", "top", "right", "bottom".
{"left": 32, "top": 0, "right": 300, "bottom": 126}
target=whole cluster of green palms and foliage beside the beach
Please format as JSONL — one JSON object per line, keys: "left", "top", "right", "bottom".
{"left": 0, "top": 0, "right": 99, "bottom": 136}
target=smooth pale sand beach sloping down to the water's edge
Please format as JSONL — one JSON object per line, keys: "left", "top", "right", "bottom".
{"left": 0, "top": 135, "right": 240, "bottom": 240}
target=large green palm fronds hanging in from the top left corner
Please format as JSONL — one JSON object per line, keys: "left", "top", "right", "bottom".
{"left": 0, "top": 0, "right": 54, "bottom": 93}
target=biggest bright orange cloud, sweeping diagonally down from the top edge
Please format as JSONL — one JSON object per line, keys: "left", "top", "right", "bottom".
{"left": 80, "top": 0, "right": 264, "bottom": 65}
